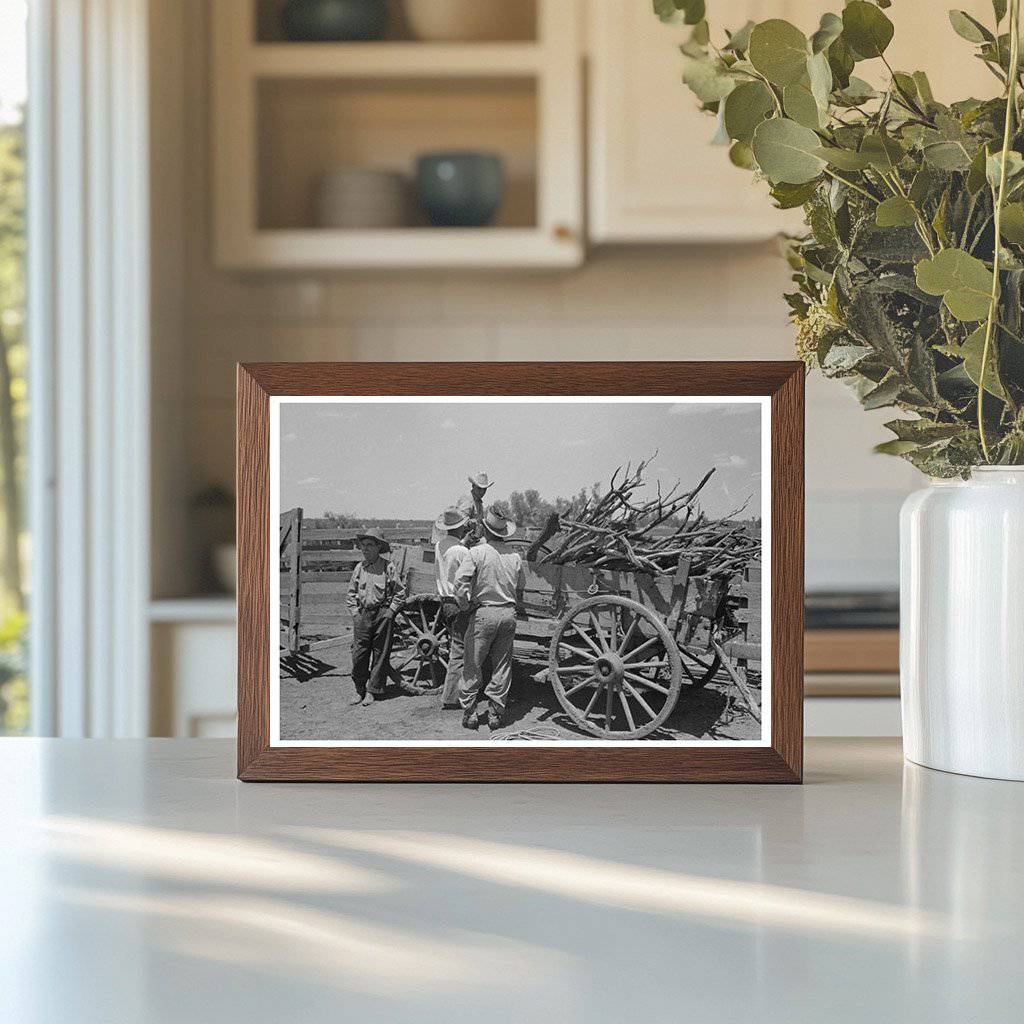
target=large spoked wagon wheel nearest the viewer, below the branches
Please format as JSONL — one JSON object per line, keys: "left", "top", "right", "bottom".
{"left": 548, "top": 594, "right": 683, "bottom": 739}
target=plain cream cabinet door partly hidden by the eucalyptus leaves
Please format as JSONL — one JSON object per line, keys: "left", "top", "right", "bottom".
{"left": 588, "top": 0, "right": 822, "bottom": 243}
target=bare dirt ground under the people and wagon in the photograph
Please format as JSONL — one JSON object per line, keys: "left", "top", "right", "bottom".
{"left": 281, "top": 642, "right": 761, "bottom": 740}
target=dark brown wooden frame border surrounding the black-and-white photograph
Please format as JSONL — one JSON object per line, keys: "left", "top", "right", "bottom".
{"left": 237, "top": 361, "right": 804, "bottom": 782}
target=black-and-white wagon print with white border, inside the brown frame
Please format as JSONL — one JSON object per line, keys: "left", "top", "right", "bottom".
{"left": 270, "top": 396, "right": 771, "bottom": 745}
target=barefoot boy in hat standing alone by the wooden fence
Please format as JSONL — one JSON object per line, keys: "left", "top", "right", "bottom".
{"left": 347, "top": 529, "right": 406, "bottom": 706}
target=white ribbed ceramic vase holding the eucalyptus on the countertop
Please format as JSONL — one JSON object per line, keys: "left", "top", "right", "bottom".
{"left": 900, "top": 466, "right": 1024, "bottom": 781}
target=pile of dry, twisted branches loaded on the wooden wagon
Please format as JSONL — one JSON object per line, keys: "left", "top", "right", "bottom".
{"left": 530, "top": 453, "right": 761, "bottom": 580}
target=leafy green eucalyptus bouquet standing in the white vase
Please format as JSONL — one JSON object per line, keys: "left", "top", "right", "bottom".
{"left": 654, "top": 0, "right": 1024, "bottom": 477}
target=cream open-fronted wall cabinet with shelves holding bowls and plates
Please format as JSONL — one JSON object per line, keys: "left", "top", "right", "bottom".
{"left": 211, "top": 0, "right": 584, "bottom": 269}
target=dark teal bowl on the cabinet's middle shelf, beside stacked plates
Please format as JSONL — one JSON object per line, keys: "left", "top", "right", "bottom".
{"left": 416, "top": 153, "right": 505, "bottom": 227}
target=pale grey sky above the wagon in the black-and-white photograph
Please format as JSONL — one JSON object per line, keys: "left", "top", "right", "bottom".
{"left": 280, "top": 401, "right": 761, "bottom": 519}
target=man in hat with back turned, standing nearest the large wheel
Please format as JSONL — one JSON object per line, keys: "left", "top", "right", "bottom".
{"left": 455, "top": 506, "right": 526, "bottom": 729}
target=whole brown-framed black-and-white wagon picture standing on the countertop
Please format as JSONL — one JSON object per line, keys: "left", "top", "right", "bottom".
{"left": 238, "top": 362, "right": 804, "bottom": 782}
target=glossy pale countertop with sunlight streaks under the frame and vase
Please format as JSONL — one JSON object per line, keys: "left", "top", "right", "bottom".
{"left": 0, "top": 739, "right": 1024, "bottom": 1024}
